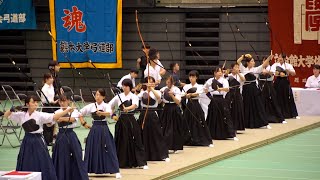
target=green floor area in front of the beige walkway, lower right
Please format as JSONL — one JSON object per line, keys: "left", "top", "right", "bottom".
{"left": 175, "top": 128, "right": 320, "bottom": 180}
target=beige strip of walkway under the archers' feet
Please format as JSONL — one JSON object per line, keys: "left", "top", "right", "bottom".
{"left": 90, "top": 116, "right": 320, "bottom": 180}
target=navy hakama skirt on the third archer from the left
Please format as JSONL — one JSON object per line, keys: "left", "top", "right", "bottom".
{"left": 84, "top": 120, "right": 119, "bottom": 174}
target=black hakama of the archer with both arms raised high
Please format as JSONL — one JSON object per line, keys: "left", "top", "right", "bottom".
{"left": 242, "top": 73, "right": 268, "bottom": 128}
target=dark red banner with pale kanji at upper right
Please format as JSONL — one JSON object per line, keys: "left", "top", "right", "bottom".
{"left": 268, "top": 0, "right": 320, "bottom": 87}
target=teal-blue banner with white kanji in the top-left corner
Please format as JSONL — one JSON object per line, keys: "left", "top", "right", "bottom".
{"left": 0, "top": 0, "right": 37, "bottom": 30}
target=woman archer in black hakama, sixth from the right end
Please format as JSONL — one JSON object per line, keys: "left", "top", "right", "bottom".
{"left": 183, "top": 71, "right": 213, "bottom": 147}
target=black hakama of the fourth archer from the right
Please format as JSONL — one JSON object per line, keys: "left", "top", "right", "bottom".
{"left": 226, "top": 78, "right": 245, "bottom": 131}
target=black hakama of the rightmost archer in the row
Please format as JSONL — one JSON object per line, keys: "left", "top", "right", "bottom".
{"left": 274, "top": 77, "right": 298, "bottom": 119}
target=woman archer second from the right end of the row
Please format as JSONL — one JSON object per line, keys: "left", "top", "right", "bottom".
{"left": 259, "top": 58, "right": 287, "bottom": 124}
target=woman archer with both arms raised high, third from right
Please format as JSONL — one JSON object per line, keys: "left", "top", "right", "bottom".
{"left": 237, "top": 54, "right": 272, "bottom": 129}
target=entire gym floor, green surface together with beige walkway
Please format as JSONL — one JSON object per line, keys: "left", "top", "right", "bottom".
{"left": 0, "top": 100, "right": 320, "bottom": 180}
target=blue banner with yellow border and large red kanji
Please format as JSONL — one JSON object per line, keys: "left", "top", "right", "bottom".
{"left": 49, "top": 0, "right": 122, "bottom": 68}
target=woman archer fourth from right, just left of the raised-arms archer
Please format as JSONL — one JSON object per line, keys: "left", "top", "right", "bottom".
{"left": 226, "top": 63, "right": 246, "bottom": 131}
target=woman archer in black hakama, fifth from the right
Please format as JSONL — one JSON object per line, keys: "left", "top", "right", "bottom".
{"left": 204, "top": 67, "right": 238, "bottom": 141}
